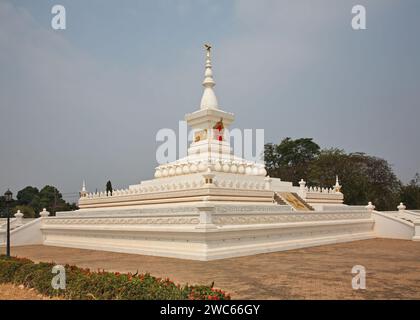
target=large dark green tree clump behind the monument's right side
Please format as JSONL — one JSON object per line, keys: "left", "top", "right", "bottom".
{"left": 264, "top": 138, "right": 402, "bottom": 210}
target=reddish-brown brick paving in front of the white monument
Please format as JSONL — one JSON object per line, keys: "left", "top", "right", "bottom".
{"left": 0, "top": 239, "right": 420, "bottom": 299}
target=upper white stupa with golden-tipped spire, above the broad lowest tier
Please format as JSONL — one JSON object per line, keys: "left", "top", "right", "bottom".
{"left": 79, "top": 45, "right": 343, "bottom": 210}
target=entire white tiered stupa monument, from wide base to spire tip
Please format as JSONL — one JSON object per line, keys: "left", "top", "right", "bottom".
{"left": 2, "top": 45, "right": 420, "bottom": 260}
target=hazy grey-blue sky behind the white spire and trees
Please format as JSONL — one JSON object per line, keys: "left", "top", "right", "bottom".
{"left": 0, "top": 0, "right": 420, "bottom": 200}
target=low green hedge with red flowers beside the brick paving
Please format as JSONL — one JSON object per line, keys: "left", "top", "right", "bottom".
{"left": 0, "top": 255, "right": 230, "bottom": 300}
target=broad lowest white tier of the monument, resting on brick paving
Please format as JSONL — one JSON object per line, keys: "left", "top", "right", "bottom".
{"left": 47, "top": 201, "right": 374, "bottom": 261}
